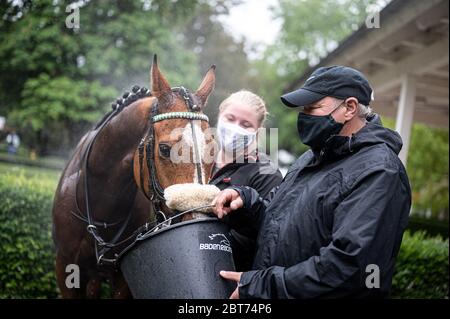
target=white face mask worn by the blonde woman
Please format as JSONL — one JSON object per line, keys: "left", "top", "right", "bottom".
{"left": 217, "top": 119, "right": 256, "bottom": 153}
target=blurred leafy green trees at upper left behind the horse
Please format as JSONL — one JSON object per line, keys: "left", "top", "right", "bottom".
{"left": 0, "top": 0, "right": 200, "bottom": 154}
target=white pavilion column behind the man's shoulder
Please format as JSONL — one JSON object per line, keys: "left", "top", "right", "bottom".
{"left": 395, "top": 74, "right": 416, "bottom": 166}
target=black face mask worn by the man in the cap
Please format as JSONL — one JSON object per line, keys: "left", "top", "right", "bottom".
{"left": 297, "top": 101, "right": 345, "bottom": 150}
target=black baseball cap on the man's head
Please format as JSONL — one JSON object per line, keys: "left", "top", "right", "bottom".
{"left": 281, "top": 65, "right": 373, "bottom": 107}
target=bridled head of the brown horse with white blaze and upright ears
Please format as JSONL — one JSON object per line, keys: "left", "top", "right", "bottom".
{"left": 134, "top": 56, "right": 216, "bottom": 219}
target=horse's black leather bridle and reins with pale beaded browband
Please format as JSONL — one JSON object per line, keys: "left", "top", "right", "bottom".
{"left": 70, "top": 86, "right": 209, "bottom": 267}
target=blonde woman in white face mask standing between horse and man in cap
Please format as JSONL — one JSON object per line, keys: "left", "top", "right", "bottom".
{"left": 210, "top": 90, "right": 282, "bottom": 270}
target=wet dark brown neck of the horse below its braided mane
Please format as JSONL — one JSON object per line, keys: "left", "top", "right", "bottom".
{"left": 79, "top": 98, "right": 155, "bottom": 220}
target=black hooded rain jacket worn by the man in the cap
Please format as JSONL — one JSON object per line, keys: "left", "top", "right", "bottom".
{"left": 229, "top": 116, "right": 411, "bottom": 298}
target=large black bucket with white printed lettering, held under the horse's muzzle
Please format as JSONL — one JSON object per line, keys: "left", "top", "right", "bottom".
{"left": 120, "top": 218, "right": 236, "bottom": 299}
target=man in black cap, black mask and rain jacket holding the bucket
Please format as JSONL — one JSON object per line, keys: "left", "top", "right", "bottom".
{"left": 213, "top": 66, "right": 411, "bottom": 298}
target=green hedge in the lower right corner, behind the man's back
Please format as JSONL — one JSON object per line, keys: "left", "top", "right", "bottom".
{"left": 392, "top": 232, "right": 449, "bottom": 299}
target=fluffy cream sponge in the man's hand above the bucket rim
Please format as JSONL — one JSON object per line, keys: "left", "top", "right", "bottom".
{"left": 164, "top": 183, "right": 220, "bottom": 213}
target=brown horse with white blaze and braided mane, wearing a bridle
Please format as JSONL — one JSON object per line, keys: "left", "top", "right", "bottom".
{"left": 53, "top": 56, "right": 215, "bottom": 298}
